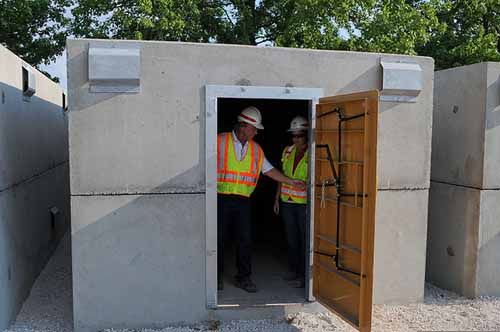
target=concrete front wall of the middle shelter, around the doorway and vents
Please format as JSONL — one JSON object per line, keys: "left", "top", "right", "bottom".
{"left": 67, "top": 40, "right": 434, "bottom": 331}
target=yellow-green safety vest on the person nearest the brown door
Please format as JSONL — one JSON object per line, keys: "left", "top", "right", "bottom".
{"left": 280, "top": 145, "right": 307, "bottom": 204}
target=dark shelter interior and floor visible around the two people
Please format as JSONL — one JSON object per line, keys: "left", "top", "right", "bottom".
{"left": 217, "top": 98, "right": 309, "bottom": 306}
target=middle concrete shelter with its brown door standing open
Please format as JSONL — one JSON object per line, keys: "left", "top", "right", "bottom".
{"left": 67, "top": 40, "right": 434, "bottom": 331}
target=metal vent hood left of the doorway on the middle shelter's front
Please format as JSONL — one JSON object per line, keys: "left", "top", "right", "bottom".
{"left": 88, "top": 43, "right": 141, "bottom": 93}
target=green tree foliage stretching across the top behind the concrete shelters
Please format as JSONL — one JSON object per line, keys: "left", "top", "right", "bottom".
{"left": 0, "top": 0, "right": 500, "bottom": 69}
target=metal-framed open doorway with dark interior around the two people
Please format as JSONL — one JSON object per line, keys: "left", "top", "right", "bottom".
{"left": 205, "top": 85, "right": 323, "bottom": 309}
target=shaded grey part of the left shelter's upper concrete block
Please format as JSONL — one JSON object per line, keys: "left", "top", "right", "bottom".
{"left": 0, "top": 83, "right": 68, "bottom": 191}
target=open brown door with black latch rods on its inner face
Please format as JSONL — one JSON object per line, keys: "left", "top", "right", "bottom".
{"left": 313, "top": 91, "right": 379, "bottom": 331}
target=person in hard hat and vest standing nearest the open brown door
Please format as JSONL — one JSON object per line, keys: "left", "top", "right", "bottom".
{"left": 274, "top": 116, "right": 309, "bottom": 288}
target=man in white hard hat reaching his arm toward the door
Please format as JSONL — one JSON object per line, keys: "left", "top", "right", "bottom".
{"left": 217, "top": 106, "right": 305, "bottom": 293}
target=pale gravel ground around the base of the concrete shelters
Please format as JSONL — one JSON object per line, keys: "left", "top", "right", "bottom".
{"left": 4, "top": 236, "right": 500, "bottom": 332}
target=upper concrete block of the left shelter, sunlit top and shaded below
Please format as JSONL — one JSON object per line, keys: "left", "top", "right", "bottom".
{"left": 0, "top": 45, "right": 68, "bottom": 191}
